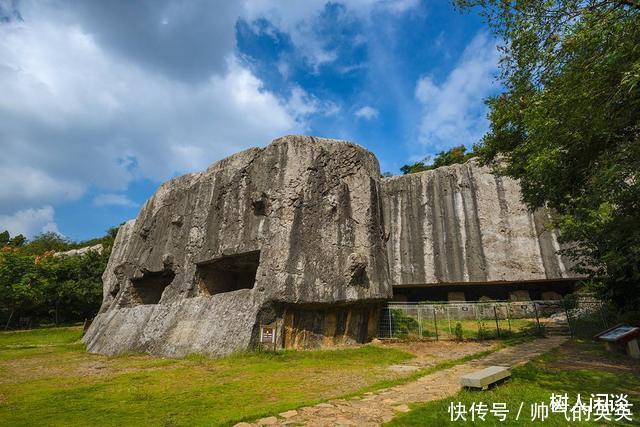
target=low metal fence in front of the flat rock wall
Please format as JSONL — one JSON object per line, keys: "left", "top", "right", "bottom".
{"left": 378, "top": 297, "right": 609, "bottom": 340}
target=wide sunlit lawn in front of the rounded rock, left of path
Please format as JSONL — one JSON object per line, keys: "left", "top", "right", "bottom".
{"left": 0, "top": 327, "right": 424, "bottom": 426}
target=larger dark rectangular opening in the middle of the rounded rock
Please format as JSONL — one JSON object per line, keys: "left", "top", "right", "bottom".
{"left": 196, "top": 251, "right": 260, "bottom": 295}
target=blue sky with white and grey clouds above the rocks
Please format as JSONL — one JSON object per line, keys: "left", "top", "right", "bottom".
{"left": 0, "top": 0, "right": 498, "bottom": 240}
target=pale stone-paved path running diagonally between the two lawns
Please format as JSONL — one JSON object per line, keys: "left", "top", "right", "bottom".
{"left": 236, "top": 336, "right": 567, "bottom": 427}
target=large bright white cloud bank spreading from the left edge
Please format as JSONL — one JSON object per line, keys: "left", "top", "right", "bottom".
{"left": 0, "top": 3, "right": 315, "bottom": 221}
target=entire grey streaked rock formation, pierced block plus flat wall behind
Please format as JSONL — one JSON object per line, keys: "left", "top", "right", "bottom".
{"left": 84, "top": 136, "right": 570, "bottom": 356}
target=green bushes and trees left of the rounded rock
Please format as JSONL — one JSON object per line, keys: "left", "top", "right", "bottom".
{"left": 0, "top": 228, "right": 117, "bottom": 328}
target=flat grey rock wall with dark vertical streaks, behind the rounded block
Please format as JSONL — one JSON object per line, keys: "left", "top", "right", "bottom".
{"left": 382, "top": 160, "right": 575, "bottom": 285}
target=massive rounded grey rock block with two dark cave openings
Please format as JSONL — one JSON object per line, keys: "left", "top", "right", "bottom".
{"left": 84, "top": 136, "right": 391, "bottom": 356}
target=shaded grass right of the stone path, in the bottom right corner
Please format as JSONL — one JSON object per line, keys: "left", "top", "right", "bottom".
{"left": 389, "top": 341, "right": 640, "bottom": 426}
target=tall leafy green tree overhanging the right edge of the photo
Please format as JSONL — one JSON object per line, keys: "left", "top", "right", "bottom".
{"left": 455, "top": 0, "right": 640, "bottom": 308}
